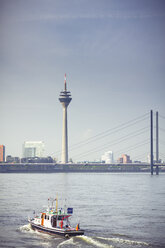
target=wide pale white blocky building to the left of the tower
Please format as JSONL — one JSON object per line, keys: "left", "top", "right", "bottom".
{"left": 23, "top": 141, "right": 45, "bottom": 158}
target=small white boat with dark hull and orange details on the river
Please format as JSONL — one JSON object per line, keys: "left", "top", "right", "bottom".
{"left": 28, "top": 198, "right": 84, "bottom": 238}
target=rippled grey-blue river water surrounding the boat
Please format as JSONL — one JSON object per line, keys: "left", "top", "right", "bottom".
{"left": 0, "top": 173, "right": 165, "bottom": 248}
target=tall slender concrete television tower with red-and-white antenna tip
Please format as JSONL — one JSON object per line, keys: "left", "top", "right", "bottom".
{"left": 59, "top": 73, "right": 72, "bottom": 164}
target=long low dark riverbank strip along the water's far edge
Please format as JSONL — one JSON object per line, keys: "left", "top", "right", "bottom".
{"left": 0, "top": 163, "right": 165, "bottom": 173}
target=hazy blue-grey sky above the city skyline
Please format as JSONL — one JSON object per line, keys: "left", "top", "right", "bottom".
{"left": 0, "top": 0, "right": 165, "bottom": 161}
